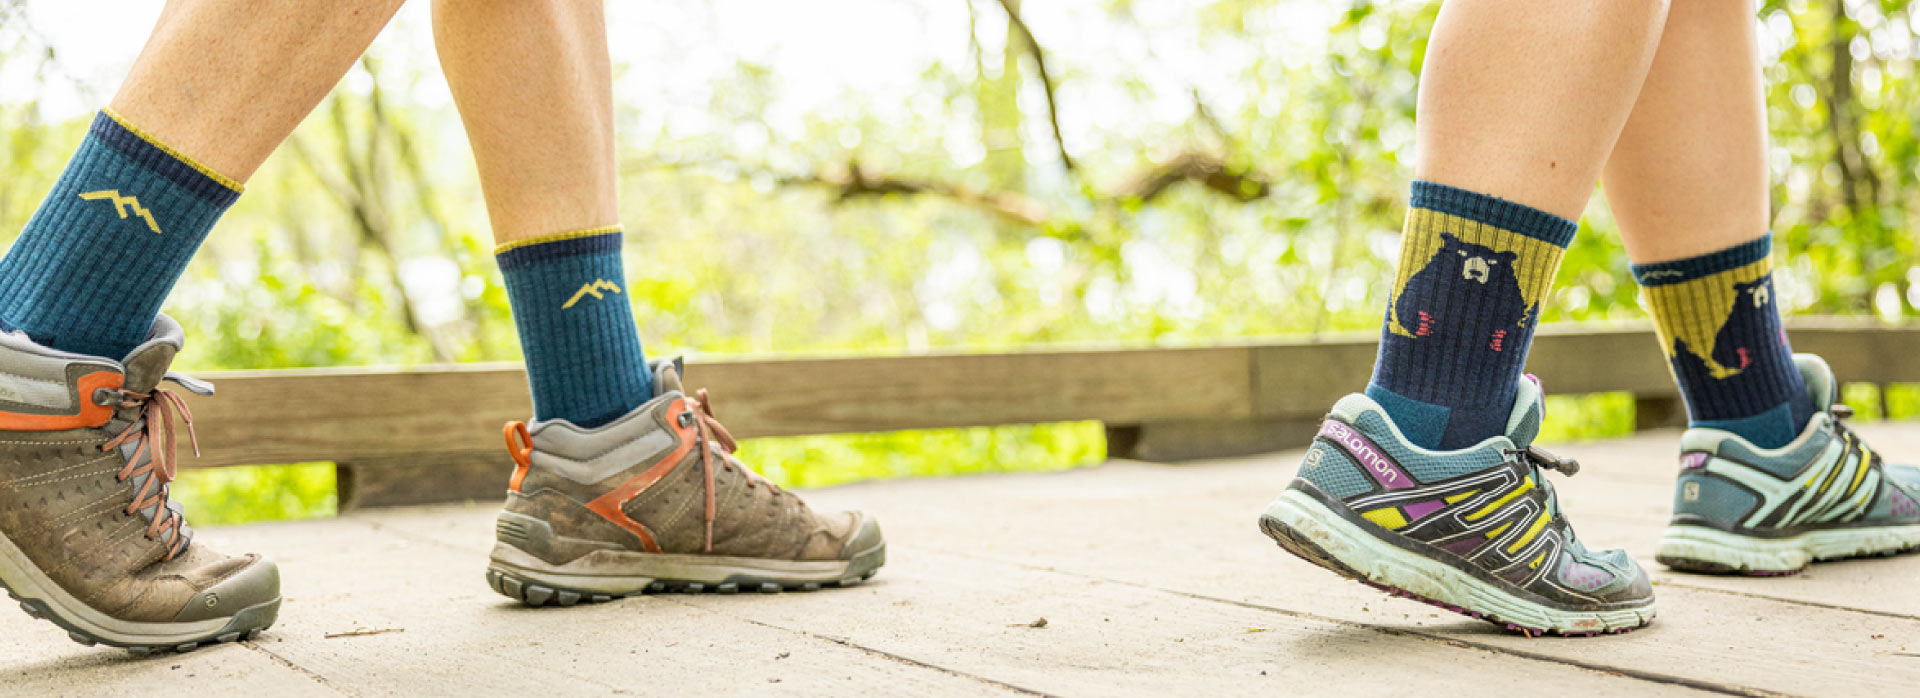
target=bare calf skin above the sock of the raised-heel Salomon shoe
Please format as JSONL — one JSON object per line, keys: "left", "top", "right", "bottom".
{"left": 1413, "top": 0, "right": 1667, "bottom": 221}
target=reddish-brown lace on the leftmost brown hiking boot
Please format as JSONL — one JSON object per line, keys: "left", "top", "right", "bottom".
{"left": 100, "top": 387, "right": 200, "bottom": 560}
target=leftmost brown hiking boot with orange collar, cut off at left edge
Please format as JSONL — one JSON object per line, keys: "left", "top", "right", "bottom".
{"left": 0, "top": 316, "right": 280, "bottom": 654}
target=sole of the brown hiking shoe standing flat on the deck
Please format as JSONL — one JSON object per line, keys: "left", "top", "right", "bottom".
{"left": 492, "top": 543, "right": 860, "bottom": 594}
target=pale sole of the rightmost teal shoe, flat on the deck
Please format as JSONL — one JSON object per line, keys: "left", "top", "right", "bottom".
{"left": 1655, "top": 524, "right": 1920, "bottom": 571}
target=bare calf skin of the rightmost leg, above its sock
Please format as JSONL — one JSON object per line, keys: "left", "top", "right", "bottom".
{"left": 1605, "top": 0, "right": 1768, "bottom": 265}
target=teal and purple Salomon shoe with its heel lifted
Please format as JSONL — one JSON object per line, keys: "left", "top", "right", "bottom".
{"left": 1260, "top": 376, "right": 1653, "bottom": 635}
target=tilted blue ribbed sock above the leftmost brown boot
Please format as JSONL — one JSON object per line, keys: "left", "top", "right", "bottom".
{"left": 0, "top": 111, "right": 240, "bottom": 359}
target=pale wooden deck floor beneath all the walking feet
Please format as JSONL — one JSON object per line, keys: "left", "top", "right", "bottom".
{"left": 0, "top": 424, "right": 1920, "bottom": 696}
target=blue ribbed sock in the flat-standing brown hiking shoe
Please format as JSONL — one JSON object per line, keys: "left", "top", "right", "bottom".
{"left": 493, "top": 226, "right": 653, "bottom": 428}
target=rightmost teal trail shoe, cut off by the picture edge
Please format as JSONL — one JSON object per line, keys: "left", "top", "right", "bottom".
{"left": 1655, "top": 355, "right": 1920, "bottom": 575}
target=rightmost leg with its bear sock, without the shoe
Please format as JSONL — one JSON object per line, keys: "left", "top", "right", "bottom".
{"left": 1607, "top": 0, "right": 1816, "bottom": 449}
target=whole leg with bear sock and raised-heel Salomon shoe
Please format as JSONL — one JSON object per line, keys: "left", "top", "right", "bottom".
{"left": 1290, "top": 0, "right": 1667, "bottom": 633}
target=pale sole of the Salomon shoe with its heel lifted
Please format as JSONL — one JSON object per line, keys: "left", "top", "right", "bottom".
{"left": 1265, "top": 489, "right": 1653, "bottom": 633}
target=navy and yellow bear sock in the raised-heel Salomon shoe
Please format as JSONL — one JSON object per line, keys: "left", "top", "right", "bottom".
{"left": 1367, "top": 182, "right": 1576, "bottom": 451}
